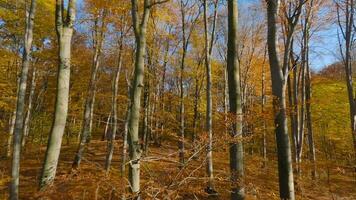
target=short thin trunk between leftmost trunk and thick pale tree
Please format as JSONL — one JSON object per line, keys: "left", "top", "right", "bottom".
{"left": 22, "top": 65, "right": 36, "bottom": 146}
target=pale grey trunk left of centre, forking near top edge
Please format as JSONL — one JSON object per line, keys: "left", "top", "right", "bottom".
{"left": 128, "top": 0, "right": 152, "bottom": 195}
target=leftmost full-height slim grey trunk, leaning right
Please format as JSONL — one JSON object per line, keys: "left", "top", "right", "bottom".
{"left": 10, "top": 0, "right": 36, "bottom": 200}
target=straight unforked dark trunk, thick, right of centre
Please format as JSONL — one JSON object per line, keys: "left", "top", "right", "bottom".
{"left": 227, "top": 0, "right": 245, "bottom": 200}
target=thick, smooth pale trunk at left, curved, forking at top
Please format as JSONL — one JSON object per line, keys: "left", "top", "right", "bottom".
{"left": 40, "top": 0, "right": 76, "bottom": 188}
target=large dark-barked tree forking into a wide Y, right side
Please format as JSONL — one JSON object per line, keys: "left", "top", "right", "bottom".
{"left": 266, "top": 0, "right": 305, "bottom": 200}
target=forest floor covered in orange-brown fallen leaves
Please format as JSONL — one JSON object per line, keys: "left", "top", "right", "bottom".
{"left": 0, "top": 140, "right": 356, "bottom": 200}
